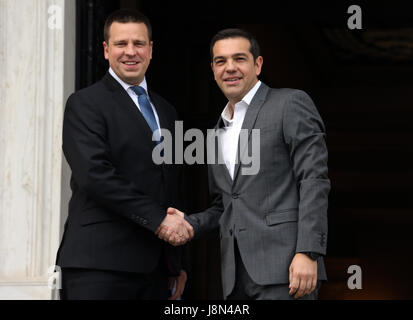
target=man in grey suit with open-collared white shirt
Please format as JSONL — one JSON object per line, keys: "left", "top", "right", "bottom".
{"left": 157, "top": 29, "right": 330, "bottom": 299}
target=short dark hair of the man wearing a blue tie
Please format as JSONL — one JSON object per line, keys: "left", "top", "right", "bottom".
{"left": 103, "top": 9, "right": 152, "bottom": 43}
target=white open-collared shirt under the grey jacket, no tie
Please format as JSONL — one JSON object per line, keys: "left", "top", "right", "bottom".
{"left": 219, "top": 80, "right": 261, "bottom": 180}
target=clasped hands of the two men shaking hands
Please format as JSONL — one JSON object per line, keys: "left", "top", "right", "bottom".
{"left": 155, "top": 208, "right": 194, "bottom": 246}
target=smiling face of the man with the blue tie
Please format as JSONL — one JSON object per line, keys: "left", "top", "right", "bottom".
{"left": 103, "top": 22, "right": 153, "bottom": 85}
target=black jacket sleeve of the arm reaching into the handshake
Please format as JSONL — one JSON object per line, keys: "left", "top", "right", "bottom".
{"left": 63, "top": 93, "right": 166, "bottom": 231}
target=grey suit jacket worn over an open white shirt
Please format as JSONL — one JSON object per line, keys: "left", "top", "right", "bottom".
{"left": 186, "top": 83, "right": 330, "bottom": 297}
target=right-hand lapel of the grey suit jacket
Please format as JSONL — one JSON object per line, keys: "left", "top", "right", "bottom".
{"left": 233, "top": 83, "right": 268, "bottom": 183}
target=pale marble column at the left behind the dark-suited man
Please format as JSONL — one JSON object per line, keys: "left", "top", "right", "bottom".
{"left": 0, "top": 0, "right": 76, "bottom": 299}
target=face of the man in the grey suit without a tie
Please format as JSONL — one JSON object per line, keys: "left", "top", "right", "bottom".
{"left": 211, "top": 37, "right": 263, "bottom": 104}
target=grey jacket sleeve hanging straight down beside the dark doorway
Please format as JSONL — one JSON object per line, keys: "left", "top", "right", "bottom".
{"left": 283, "top": 90, "right": 330, "bottom": 255}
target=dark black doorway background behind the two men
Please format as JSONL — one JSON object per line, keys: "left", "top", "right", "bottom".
{"left": 76, "top": 0, "right": 413, "bottom": 299}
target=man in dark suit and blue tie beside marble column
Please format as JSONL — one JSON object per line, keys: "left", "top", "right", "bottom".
{"left": 57, "top": 10, "right": 190, "bottom": 299}
